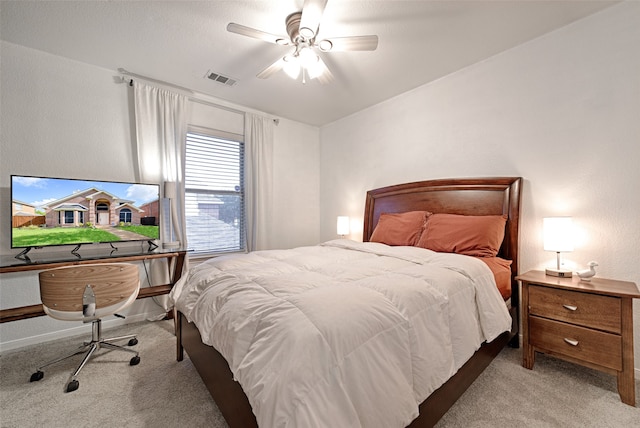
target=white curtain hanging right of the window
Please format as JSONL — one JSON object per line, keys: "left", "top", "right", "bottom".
{"left": 244, "top": 113, "right": 274, "bottom": 251}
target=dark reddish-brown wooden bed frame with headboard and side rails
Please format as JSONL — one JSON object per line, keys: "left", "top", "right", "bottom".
{"left": 176, "top": 177, "right": 522, "bottom": 428}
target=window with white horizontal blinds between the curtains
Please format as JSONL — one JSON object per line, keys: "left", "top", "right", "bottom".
{"left": 185, "top": 132, "right": 245, "bottom": 253}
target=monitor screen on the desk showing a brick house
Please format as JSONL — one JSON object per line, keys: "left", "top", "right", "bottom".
{"left": 11, "top": 175, "right": 160, "bottom": 248}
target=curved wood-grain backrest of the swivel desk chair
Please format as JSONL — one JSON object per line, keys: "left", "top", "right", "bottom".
{"left": 38, "top": 263, "right": 140, "bottom": 320}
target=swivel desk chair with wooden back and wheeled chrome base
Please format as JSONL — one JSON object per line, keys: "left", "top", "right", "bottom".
{"left": 31, "top": 263, "right": 140, "bottom": 392}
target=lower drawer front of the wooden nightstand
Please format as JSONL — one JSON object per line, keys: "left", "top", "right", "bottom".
{"left": 529, "top": 317, "right": 622, "bottom": 371}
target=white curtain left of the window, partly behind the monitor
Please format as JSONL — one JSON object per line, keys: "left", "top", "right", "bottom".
{"left": 134, "top": 80, "right": 188, "bottom": 311}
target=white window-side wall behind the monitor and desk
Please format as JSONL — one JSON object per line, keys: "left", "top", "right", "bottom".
{"left": 0, "top": 42, "right": 319, "bottom": 350}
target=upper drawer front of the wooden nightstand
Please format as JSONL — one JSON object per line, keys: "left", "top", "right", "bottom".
{"left": 529, "top": 285, "right": 622, "bottom": 334}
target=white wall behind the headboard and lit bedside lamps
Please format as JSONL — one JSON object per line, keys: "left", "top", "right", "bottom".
{"left": 320, "top": 2, "right": 640, "bottom": 376}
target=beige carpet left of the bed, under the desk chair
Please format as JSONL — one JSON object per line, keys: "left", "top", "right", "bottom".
{"left": 0, "top": 321, "right": 227, "bottom": 428}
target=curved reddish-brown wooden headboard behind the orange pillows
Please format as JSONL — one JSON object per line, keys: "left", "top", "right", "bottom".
{"left": 363, "top": 177, "right": 522, "bottom": 280}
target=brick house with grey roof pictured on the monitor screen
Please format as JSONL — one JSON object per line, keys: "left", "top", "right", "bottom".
{"left": 43, "top": 187, "right": 144, "bottom": 227}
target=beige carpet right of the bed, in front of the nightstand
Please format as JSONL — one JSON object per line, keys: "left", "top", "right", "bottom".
{"left": 437, "top": 348, "right": 640, "bottom": 428}
